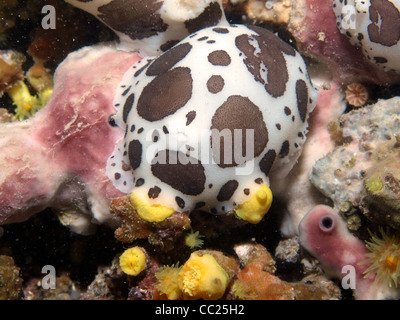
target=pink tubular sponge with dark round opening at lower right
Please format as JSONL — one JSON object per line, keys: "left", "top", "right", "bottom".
{"left": 299, "top": 205, "right": 392, "bottom": 300}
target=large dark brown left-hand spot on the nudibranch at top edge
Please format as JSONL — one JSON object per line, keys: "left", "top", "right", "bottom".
{"left": 97, "top": 0, "right": 168, "bottom": 40}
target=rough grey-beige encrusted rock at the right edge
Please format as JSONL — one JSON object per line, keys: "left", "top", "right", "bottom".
{"left": 311, "top": 97, "right": 400, "bottom": 230}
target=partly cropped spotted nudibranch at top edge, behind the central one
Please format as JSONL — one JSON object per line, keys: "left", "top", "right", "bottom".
{"left": 65, "top": 0, "right": 228, "bottom": 56}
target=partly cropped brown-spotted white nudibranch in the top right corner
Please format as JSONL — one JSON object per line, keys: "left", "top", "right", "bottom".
{"left": 333, "top": 0, "right": 400, "bottom": 73}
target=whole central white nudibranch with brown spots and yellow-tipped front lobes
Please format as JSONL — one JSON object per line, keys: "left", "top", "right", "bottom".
{"left": 107, "top": 25, "right": 317, "bottom": 223}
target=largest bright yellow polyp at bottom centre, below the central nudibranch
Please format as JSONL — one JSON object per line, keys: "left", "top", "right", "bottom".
{"left": 179, "top": 252, "right": 229, "bottom": 300}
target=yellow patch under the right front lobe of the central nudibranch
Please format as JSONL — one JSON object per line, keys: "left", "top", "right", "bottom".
{"left": 235, "top": 184, "right": 272, "bottom": 223}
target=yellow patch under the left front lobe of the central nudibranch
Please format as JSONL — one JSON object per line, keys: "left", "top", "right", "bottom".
{"left": 130, "top": 192, "right": 175, "bottom": 222}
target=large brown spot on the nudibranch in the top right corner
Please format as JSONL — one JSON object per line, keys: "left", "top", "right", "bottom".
{"left": 367, "top": 0, "right": 400, "bottom": 47}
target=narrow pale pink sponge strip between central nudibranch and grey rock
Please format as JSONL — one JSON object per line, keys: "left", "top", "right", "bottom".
{"left": 276, "top": 81, "right": 346, "bottom": 237}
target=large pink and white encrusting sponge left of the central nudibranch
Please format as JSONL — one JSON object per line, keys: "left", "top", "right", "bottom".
{"left": 0, "top": 45, "right": 141, "bottom": 232}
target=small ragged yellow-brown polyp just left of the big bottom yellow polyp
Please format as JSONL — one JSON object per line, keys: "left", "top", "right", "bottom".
{"left": 155, "top": 265, "right": 182, "bottom": 300}
